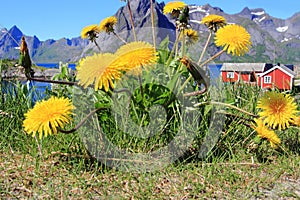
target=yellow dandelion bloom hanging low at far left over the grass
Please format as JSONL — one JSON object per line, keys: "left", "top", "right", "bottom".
{"left": 23, "top": 97, "right": 75, "bottom": 138}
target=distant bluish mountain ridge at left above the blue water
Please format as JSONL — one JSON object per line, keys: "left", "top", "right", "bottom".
{"left": 0, "top": 25, "right": 88, "bottom": 62}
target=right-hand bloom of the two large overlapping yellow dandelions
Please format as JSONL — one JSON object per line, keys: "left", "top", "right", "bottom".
{"left": 111, "top": 41, "right": 158, "bottom": 75}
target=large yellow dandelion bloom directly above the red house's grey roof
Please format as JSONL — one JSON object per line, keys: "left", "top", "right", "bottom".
{"left": 215, "top": 24, "right": 251, "bottom": 56}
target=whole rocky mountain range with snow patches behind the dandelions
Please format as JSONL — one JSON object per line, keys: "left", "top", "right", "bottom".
{"left": 0, "top": 0, "right": 300, "bottom": 64}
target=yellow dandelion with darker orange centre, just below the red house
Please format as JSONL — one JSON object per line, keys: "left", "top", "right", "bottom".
{"left": 257, "top": 91, "right": 298, "bottom": 130}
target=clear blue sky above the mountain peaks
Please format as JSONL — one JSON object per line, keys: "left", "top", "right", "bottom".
{"left": 0, "top": 0, "right": 300, "bottom": 41}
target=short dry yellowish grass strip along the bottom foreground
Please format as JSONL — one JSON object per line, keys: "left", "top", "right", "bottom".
{"left": 0, "top": 152, "right": 300, "bottom": 199}
